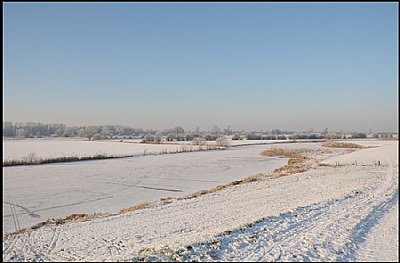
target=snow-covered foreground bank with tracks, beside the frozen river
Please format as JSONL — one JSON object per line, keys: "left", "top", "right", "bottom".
{"left": 3, "top": 141, "right": 399, "bottom": 262}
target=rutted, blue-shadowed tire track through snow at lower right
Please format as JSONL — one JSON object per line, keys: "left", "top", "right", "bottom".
{"left": 133, "top": 166, "right": 399, "bottom": 261}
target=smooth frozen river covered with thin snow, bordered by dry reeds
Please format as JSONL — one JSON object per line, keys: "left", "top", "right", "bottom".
{"left": 3, "top": 145, "right": 294, "bottom": 232}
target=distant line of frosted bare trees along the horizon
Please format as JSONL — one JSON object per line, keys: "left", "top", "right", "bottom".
{"left": 3, "top": 121, "right": 378, "bottom": 143}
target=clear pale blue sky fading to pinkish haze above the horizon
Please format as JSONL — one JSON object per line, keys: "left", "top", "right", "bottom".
{"left": 3, "top": 2, "right": 399, "bottom": 131}
